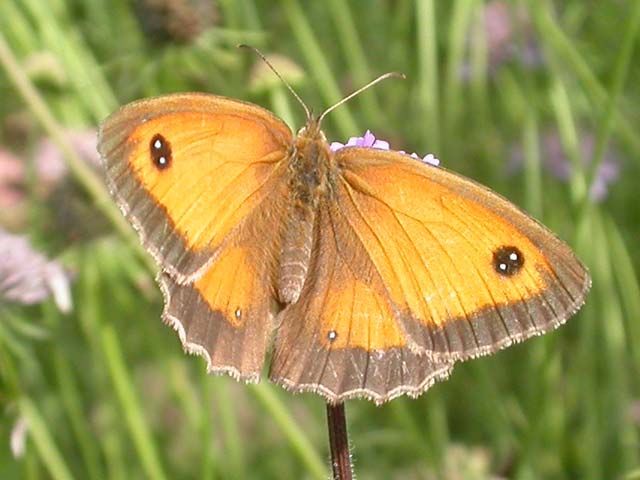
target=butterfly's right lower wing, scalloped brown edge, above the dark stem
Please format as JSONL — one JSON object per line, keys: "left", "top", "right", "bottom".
{"left": 270, "top": 197, "right": 452, "bottom": 404}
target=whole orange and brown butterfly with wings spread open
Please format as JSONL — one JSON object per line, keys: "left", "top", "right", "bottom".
{"left": 98, "top": 76, "right": 590, "bottom": 404}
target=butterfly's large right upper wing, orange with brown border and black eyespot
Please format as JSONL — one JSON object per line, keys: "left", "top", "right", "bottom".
{"left": 336, "top": 148, "right": 590, "bottom": 359}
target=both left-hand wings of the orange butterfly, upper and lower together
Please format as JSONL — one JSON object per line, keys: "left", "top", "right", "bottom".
{"left": 98, "top": 94, "right": 292, "bottom": 381}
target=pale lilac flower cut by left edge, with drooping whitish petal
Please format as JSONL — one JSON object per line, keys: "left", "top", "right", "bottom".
{"left": 0, "top": 229, "right": 72, "bottom": 313}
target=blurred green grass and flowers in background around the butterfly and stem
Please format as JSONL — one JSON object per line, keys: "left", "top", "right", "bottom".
{"left": 0, "top": 0, "right": 640, "bottom": 480}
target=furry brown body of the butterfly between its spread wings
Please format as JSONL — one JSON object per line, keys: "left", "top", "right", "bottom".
{"left": 277, "top": 124, "right": 333, "bottom": 304}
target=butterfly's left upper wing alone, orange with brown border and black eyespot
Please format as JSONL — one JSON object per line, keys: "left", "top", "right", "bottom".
{"left": 98, "top": 93, "right": 292, "bottom": 283}
